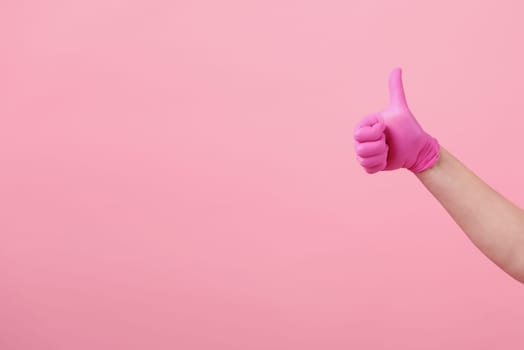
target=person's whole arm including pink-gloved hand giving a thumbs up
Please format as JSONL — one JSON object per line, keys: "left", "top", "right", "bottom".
{"left": 354, "top": 68, "right": 524, "bottom": 283}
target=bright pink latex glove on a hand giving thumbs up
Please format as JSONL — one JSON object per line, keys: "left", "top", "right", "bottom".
{"left": 354, "top": 68, "right": 440, "bottom": 174}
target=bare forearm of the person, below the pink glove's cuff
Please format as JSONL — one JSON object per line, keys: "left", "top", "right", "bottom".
{"left": 416, "top": 146, "right": 524, "bottom": 283}
